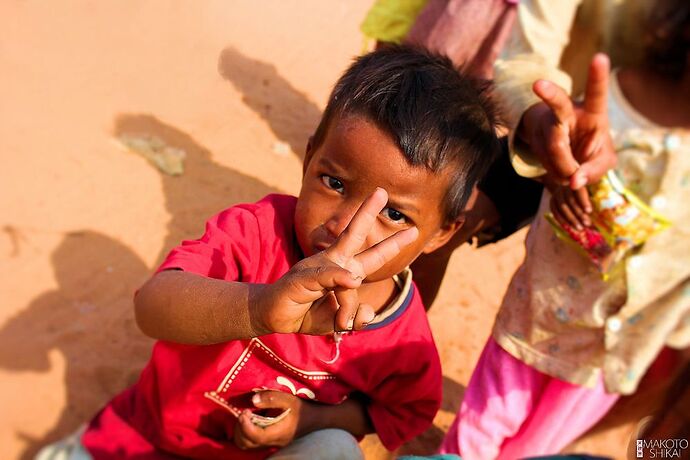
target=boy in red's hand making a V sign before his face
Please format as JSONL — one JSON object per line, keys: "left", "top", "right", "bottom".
{"left": 256, "top": 188, "right": 418, "bottom": 334}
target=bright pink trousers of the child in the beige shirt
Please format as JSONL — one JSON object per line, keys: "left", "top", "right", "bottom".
{"left": 441, "top": 338, "right": 619, "bottom": 460}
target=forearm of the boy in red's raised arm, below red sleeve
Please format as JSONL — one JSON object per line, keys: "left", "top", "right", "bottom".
{"left": 134, "top": 270, "right": 268, "bottom": 345}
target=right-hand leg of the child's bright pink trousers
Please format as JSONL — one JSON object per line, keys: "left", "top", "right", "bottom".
{"left": 498, "top": 372, "right": 620, "bottom": 459}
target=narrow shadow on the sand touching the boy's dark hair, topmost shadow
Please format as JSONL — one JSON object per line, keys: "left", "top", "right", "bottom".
{"left": 218, "top": 47, "right": 321, "bottom": 159}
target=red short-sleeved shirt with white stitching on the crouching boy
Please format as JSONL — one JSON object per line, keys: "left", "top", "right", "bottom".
{"left": 82, "top": 195, "right": 441, "bottom": 459}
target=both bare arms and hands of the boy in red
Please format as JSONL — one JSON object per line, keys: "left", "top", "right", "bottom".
{"left": 135, "top": 189, "right": 408, "bottom": 449}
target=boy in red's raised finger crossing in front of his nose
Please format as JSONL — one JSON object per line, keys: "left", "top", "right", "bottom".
{"left": 326, "top": 187, "right": 388, "bottom": 265}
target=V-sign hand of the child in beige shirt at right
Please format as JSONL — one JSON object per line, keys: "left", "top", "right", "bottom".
{"left": 520, "top": 54, "right": 616, "bottom": 213}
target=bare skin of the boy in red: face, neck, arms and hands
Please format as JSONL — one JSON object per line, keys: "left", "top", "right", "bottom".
{"left": 135, "top": 116, "right": 463, "bottom": 449}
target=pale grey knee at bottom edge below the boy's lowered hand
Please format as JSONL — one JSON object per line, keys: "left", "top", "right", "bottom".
{"left": 270, "top": 429, "right": 364, "bottom": 460}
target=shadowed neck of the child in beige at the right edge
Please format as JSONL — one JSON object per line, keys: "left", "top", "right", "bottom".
{"left": 618, "top": 68, "right": 690, "bottom": 129}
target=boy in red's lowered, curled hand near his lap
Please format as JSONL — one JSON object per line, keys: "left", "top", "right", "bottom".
{"left": 235, "top": 390, "right": 315, "bottom": 449}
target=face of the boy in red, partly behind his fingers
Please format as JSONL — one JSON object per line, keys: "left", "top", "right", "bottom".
{"left": 295, "top": 115, "right": 462, "bottom": 282}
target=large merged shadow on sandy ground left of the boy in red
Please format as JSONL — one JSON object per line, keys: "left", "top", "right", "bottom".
{"left": 0, "top": 115, "right": 275, "bottom": 459}
